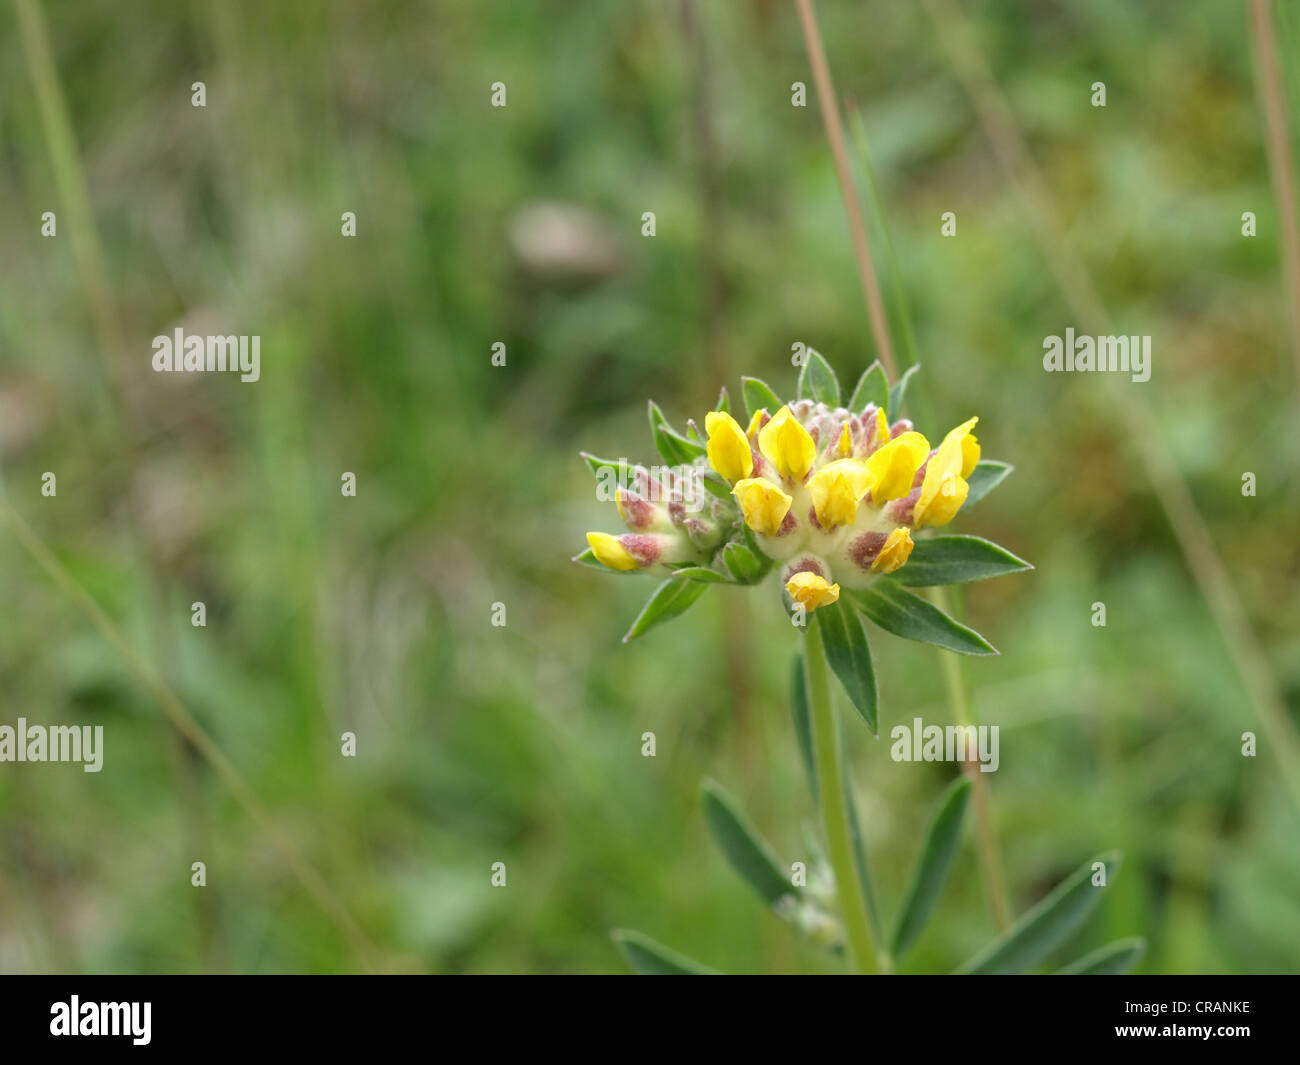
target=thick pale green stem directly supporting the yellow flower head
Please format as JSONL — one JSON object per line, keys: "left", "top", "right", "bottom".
{"left": 805, "top": 615, "right": 875, "bottom": 973}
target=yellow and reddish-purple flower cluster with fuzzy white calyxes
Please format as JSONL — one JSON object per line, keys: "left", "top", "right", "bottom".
{"left": 588, "top": 369, "right": 980, "bottom": 610}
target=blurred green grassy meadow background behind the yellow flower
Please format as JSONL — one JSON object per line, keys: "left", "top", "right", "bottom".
{"left": 0, "top": 0, "right": 1300, "bottom": 973}
